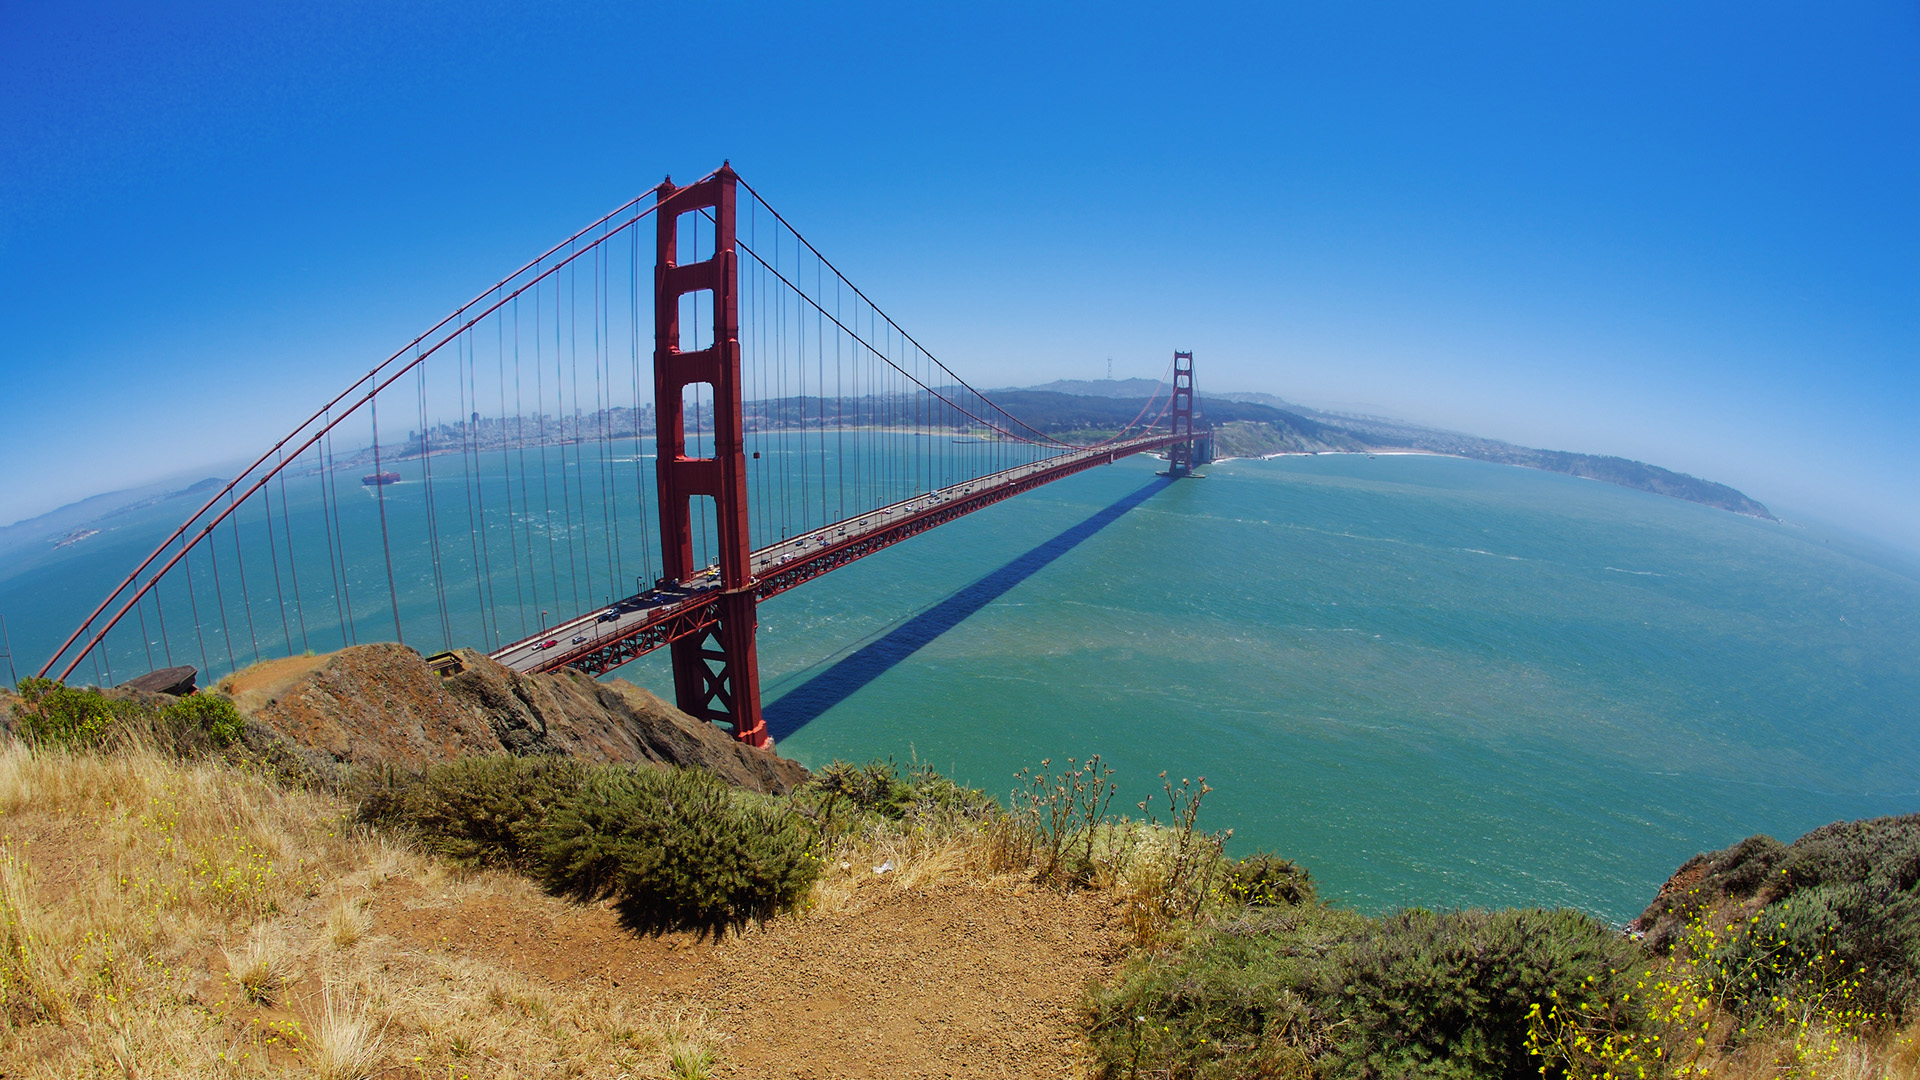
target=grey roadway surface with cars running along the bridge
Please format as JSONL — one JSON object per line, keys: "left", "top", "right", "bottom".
{"left": 492, "top": 438, "right": 1164, "bottom": 673}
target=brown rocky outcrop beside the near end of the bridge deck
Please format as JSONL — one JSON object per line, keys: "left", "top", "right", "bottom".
{"left": 219, "top": 644, "right": 806, "bottom": 794}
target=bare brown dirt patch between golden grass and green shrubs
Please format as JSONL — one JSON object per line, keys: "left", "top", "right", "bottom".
{"left": 371, "top": 864, "right": 1119, "bottom": 1080}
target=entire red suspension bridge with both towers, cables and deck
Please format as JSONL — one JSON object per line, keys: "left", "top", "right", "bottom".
{"left": 40, "top": 165, "right": 1208, "bottom": 746}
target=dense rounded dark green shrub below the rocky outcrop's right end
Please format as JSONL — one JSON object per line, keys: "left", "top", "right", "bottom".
{"left": 540, "top": 769, "right": 820, "bottom": 936}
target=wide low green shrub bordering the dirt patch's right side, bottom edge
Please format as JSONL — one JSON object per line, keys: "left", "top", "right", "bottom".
{"left": 1089, "top": 903, "right": 1638, "bottom": 1080}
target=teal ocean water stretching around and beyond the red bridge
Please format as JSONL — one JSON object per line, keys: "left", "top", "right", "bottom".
{"left": 0, "top": 445, "right": 1920, "bottom": 922}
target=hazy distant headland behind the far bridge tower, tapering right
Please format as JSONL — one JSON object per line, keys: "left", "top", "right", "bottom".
{"left": 991, "top": 379, "right": 1778, "bottom": 521}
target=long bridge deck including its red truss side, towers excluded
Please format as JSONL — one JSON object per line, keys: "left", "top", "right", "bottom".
{"left": 492, "top": 434, "right": 1190, "bottom": 675}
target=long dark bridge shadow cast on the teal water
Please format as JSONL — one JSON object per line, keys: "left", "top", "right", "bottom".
{"left": 766, "top": 477, "right": 1171, "bottom": 742}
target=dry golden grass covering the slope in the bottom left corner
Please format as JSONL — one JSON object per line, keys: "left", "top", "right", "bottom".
{"left": 0, "top": 746, "right": 718, "bottom": 1080}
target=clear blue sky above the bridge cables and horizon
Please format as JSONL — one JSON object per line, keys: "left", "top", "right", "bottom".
{"left": 0, "top": 2, "right": 1920, "bottom": 550}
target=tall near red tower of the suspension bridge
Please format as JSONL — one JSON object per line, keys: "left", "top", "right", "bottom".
{"left": 653, "top": 165, "right": 768, "bottom": 746}
